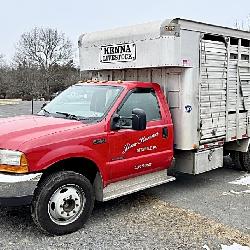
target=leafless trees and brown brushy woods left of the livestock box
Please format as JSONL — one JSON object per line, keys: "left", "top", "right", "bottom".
{"left": 0, "top": 28, "right": 80, "bottom": 100}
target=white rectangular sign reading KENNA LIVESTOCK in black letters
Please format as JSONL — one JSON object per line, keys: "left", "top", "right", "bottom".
{"left": 100, "top": 43, "right": 136, "bottom": 63}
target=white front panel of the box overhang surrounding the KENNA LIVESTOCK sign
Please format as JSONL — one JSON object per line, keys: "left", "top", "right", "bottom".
{"left": 79, "top": 34, "right": 183, "bottom": 71}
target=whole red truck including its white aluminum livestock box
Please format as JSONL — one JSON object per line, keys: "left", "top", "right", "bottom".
{"left": 0, "top": 19, "right": 250, "bottom": 235}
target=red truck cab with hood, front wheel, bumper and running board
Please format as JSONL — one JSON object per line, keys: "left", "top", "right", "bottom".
{"left": 0, "top": 81, "right": 174, "bottom": 235}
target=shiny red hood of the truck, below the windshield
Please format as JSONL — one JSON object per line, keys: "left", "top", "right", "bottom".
{"left": 0, "top": 115, "right": 86, "bottom": 150}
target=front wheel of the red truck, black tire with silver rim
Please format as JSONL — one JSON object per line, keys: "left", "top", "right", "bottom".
{"left": 31, "top": 171, "right": 94, "bottom": 235}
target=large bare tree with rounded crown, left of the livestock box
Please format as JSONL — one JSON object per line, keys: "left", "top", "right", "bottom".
{"left": 14, "top": 28, "right": 77, "bottom": 98}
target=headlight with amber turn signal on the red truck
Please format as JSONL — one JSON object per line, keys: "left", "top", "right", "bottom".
{"left": 0, "top": 150, "right": 28, "bottom": 173}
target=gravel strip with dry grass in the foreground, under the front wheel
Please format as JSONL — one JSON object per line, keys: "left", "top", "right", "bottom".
{"left": 0, "top": 189, "right": 250, "bottom": 249}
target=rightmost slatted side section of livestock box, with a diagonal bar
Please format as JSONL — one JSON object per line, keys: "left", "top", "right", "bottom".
{"left": 227, "top": 38, "right": 250, "bottom": 141}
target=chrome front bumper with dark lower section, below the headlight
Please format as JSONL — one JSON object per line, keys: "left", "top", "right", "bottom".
{"left": 0, "top": 173, "right": 42, "bottom": 206}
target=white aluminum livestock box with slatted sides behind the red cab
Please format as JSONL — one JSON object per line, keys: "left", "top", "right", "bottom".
{"left": 79, "top": 18, "right": 250, "bottom": 173}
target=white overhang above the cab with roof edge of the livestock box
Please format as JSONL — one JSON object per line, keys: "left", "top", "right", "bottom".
{"left": 78, "top": 18, "right": 250, "bottom": 70}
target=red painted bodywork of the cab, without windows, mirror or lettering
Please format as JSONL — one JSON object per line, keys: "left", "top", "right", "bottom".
{"left": 0, "top": 82, "right": 173, "bottom": 185}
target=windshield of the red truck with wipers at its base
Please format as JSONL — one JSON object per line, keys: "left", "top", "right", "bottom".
{"left": 38, "top": 84, "right": 122, "bottom": 120}
